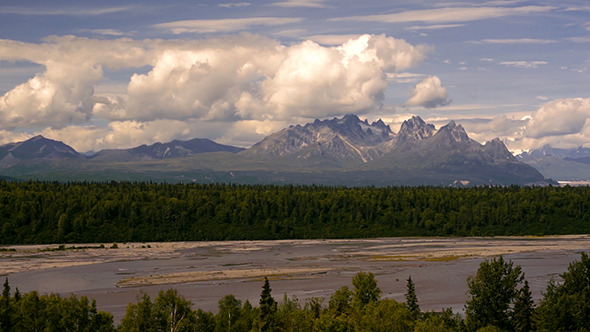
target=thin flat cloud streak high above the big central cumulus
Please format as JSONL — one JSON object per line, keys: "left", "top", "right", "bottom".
{"left": 153, "top": 17, "right": 303, "bottom": 35}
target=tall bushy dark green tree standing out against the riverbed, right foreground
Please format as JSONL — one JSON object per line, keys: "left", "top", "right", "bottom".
{"left": 465, "top": 256, "right": 524, "bottom": 331}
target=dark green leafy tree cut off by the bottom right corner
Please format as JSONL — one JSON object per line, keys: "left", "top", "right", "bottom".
{"left": 535, "top": 253, "right": 590, "bottom": 331}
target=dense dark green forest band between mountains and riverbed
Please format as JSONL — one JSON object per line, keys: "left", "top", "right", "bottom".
{"left": 0, "top": 181, "right": 590, "bottom": 244}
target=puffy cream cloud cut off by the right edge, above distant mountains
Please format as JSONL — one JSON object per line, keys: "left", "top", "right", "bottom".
{"left": 525, "top": 98, "right": 590, "bottom": 138}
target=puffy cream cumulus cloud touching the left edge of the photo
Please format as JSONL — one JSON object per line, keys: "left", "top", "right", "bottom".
{"left": 0, "top": 36, "right": 153, "bottom": 128}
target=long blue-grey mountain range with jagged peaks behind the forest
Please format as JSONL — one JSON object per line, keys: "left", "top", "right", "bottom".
{"left": 0, "top": 114, "right": 551, "bottom": 186}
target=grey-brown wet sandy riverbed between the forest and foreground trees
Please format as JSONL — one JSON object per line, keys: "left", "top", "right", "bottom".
{"left": 0, "top": 236, "right": 590, "bottom": 321}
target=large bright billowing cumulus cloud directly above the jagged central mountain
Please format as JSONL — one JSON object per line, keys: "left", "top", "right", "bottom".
{"left": 127, "top": 35, "right": 426, "bottom": 120}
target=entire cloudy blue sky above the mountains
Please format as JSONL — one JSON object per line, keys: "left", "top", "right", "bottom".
{"left": 0, "top": 0, "right": 590, "bottom": 153}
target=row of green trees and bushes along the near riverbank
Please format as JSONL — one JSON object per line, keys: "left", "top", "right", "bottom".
{"left": 0, "top": 254, "right": 590, "bottom": 332}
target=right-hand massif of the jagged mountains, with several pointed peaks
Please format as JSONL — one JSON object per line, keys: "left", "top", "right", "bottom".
{"left": 367, "top": 118, "right": 544, "bottom": 185}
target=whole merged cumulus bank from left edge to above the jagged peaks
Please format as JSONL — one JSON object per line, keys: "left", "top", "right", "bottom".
{"left": 0, "top": 34, "right": 429, "bottom": 150}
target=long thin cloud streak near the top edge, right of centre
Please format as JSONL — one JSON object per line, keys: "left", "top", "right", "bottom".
{"left": 332, "top": 6, "right": 556, "bottom": 23}
